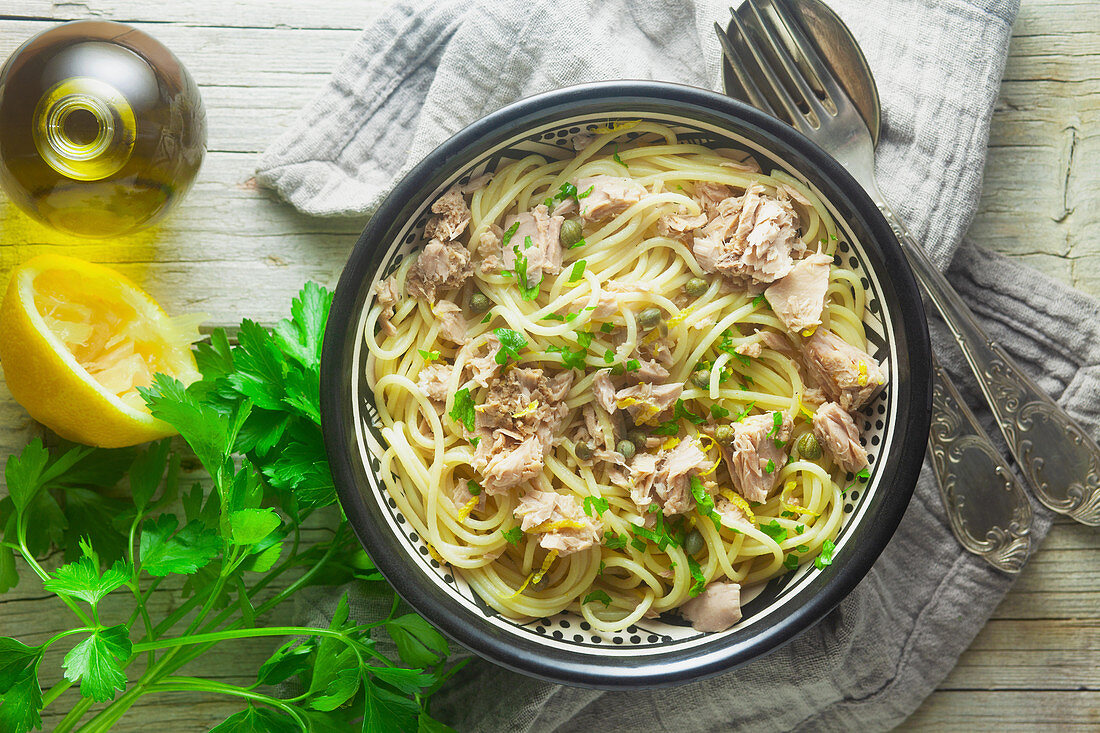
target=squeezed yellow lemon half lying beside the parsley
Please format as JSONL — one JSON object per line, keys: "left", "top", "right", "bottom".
{"left": 0, "top": 254, "right": 204, "bottom": 448}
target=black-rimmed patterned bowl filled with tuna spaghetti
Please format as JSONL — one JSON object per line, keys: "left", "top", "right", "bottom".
{"left": 321, "top": 81, "right": 931, "bottom": 689}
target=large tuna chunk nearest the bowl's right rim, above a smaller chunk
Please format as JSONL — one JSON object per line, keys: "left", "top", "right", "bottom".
{"left": 802, "top": 328, "right": 887, "bottom": 409}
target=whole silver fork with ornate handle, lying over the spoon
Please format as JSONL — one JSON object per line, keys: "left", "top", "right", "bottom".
{"left": 718, "top": 0, "right": 1100, "bottom": 526}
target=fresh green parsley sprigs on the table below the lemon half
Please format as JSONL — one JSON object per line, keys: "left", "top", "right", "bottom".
{"left": 0, "top": 284, "right": 460, "bottom": 733}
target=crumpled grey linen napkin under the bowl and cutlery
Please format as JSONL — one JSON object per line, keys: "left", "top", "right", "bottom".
{"left": 257, "top": 0, "right": 1100, "bottom": 733}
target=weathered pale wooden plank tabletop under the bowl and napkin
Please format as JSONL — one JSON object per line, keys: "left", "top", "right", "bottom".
{"left": 0, "top": 0, "right": 1100, "bottom": 731}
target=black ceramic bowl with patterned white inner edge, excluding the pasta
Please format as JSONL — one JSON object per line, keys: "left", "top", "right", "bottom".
{"left": 321, "top": 81, "right": 931, "bottom": 689}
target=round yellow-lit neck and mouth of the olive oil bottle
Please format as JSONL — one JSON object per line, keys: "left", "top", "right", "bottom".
{"left": 33, "top": 77, "right": 136, "bottom": 180}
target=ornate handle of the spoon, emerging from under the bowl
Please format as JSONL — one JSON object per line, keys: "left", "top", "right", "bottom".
{"left": 928, "top": 358, "right": 1032, "bottom": 572}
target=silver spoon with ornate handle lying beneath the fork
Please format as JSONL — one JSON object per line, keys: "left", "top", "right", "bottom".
{"left": 717, "top": 0, "right": 1032, "bottom": 572}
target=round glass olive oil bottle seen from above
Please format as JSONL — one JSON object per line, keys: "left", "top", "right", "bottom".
{"left": 0, "top": 21, "right": 206, "bottom": 237}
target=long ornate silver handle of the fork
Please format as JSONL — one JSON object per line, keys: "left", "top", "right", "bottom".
{"left": 878, "top": 199, "right": 1100, "bottom": 526}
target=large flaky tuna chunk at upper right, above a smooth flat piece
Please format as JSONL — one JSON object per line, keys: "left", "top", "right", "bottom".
{"left": 692, "top": 185, "right": 805, "bottom": 283}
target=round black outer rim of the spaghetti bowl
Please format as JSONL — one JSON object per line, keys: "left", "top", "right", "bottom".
{"left": 320, "top": 80, "right": 932, "bottom": 689}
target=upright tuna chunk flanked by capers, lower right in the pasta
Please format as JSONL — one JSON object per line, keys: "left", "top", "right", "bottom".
{"left": 722, "top": 413, "right": 792, "bottom": 502}
